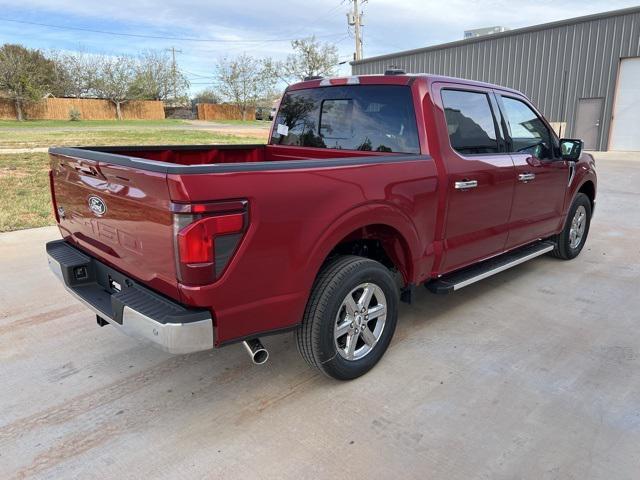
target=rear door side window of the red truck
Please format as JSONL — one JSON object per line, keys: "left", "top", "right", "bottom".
{"left": 442, "top": 90, "right": 500, "bottom": 154}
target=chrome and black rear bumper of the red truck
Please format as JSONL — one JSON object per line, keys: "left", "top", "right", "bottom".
{"left": 47, "top": 240, "right": 213, "bottom": 354}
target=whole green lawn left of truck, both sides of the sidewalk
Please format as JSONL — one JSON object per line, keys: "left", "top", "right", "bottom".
{"left": 0, "top": 129, "right": 266, "bottom": 232}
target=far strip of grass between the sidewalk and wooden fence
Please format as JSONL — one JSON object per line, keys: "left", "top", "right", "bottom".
{"left": 0, "top": 128, "right": 268, "bottom": 148}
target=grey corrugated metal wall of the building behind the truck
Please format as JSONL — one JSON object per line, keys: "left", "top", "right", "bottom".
{"left": 352, "top": 8, "right": 640, "bottom": 150}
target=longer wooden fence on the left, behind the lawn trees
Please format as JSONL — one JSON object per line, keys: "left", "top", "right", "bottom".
{"left": 0, "top": 98, "right": 164, "bottom": 120}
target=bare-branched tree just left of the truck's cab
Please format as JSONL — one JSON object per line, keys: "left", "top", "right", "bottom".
{"left": 218, "top": 54, "right": 276, "bottom": 120}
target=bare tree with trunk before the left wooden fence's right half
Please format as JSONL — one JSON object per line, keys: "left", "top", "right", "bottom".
{"left": 93, "top": 55, "right": 137, "bottom": 120}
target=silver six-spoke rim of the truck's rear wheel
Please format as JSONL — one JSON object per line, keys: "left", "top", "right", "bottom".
{"left": 333, "top": 282, "right": 387, "bottom": 361}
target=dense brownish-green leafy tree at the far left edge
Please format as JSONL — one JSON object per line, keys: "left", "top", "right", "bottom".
{"left": 0, "top": 44, "right": 56, "bottom": 121}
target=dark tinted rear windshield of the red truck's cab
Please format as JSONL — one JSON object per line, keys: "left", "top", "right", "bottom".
{"left": 271, "top": 85, "right": 420, "bottom": 153}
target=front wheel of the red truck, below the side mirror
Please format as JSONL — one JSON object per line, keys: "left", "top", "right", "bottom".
{"left": 551, "top": 193, "right": 591, "bottom": 260}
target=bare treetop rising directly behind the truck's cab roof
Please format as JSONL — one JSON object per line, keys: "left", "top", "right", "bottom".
{"left": 279, "top": 36, "right": 338, "bottom": 82}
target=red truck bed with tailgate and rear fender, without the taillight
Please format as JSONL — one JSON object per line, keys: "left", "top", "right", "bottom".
{"left": 49, "top": 141, "right": 437, "bottom": 345}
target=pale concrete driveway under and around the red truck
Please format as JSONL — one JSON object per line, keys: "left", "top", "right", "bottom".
{"left": 0, "top": 158, "right": 640, "bottom": 480}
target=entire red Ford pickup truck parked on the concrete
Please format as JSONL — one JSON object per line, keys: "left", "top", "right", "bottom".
{"left": 47, "top": 71, "right": 596, "bottom": 379}
